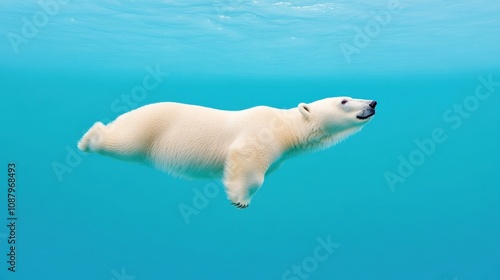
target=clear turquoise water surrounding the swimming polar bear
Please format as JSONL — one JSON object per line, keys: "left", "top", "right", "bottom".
{"left": 0, "top": 0, "right": 500, "bottom": 280}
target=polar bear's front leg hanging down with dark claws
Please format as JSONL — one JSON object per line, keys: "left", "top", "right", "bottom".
{"left": 224, "top": 149, "right": 267, "bottom": 209}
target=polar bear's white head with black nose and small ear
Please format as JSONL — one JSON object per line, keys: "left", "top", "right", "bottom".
{"left": 298, "top": 97, "right": 377, "bottom": 149}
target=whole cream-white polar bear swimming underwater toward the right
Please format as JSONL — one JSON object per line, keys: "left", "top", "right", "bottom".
{"left": 78, "top": 97, "right": 377, "bottom": 208}
